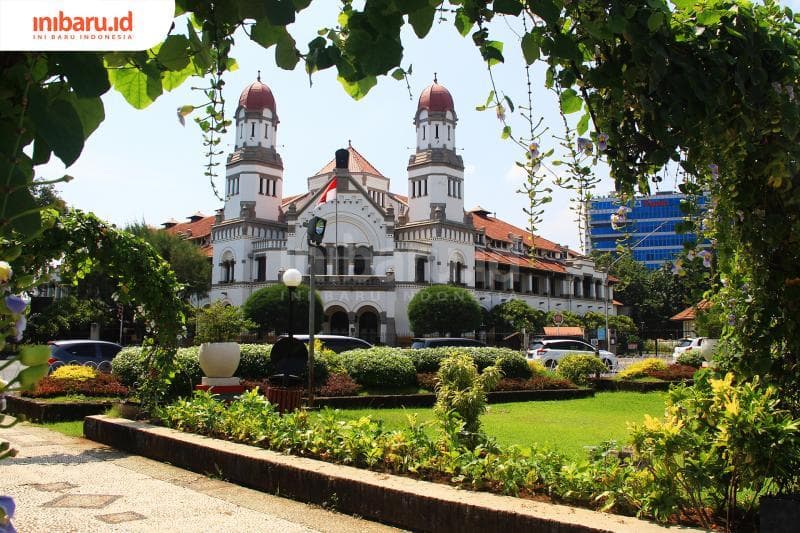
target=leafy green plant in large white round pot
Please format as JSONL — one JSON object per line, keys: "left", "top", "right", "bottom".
{"left": 196, "top": 301, "right": 255, "bottom": 378}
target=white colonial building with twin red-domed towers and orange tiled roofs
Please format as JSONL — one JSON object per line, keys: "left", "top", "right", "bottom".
{"left": 192, "top": 80, "right": 615, "bottom": 344}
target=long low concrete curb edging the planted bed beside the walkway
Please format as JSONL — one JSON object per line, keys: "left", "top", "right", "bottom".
{"left": 84, "top": 416, "right": 685, "bottom": 533}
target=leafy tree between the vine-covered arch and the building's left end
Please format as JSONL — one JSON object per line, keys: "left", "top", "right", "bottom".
{"left": 125, "top": 223, "right": 211, "bottom": 299}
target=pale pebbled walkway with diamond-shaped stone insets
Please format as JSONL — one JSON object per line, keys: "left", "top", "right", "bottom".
{"left": 0, "top": 424, "right": 397, "bottom": 533}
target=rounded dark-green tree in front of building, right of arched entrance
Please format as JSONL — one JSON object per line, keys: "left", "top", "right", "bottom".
{"left": 408, "top": 285, "right": 481, "bottom": 337}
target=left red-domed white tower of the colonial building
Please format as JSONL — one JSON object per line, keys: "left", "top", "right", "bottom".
{"left": 224, "top": 73, "right": 283, "bottom": 220}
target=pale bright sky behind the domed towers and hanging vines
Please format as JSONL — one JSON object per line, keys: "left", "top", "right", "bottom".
{"left": 37, "top": 0, "right": 800, "bottom": 249}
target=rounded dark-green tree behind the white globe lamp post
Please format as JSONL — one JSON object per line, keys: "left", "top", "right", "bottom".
{"left": 242, "top": 283, "right": 324, "bottom": 334}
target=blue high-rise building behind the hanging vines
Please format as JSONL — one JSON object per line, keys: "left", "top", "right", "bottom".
{"left": 587, "top": 191, "right": 708, "bottom": 270}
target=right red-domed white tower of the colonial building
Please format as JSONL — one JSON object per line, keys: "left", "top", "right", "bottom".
{"left": 408, "top": 76, "right": 464, "bottom": 222}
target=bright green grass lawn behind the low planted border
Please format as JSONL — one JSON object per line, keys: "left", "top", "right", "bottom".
{"left": 342, "top": 392, "right": 666, "bottom": 458}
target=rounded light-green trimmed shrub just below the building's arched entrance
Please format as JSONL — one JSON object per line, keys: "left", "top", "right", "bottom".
{"left": 343, "top": 348, "right": 416, "bottom": 387}
